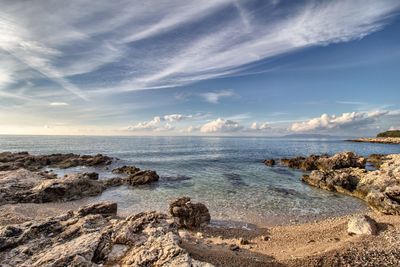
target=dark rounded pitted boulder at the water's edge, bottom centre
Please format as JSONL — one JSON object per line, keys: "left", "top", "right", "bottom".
{"left": 169, "top": 197, "right": 211, "bottom": 229}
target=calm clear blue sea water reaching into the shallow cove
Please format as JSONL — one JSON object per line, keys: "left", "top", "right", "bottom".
{"left": 0, "top": 136, "right": 400, "bottom": 225}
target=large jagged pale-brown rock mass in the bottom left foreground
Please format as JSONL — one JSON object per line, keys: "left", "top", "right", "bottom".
{"left": 0, "top": 202, "right": 211, "bottom": 267}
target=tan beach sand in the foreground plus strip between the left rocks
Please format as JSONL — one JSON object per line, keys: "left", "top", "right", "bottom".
{"left": 0, "top": 204, "right": 400, "bottom": 266}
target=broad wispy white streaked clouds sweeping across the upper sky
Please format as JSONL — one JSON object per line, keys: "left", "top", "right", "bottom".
{"left": 0, "top": 0, "right": 400, "bottom": 99}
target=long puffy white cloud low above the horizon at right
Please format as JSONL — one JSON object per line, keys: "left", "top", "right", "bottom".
{"left": 290, "top": 111, "right": 388, "bottom": 132}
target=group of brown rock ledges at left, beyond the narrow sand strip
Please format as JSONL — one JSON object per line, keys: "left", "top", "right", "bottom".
{"left": 0, "top": 152, "right": 159, "bottom": 205}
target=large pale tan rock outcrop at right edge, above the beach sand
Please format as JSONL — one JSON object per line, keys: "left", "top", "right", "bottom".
{"left": 303, "top": 154, "right": 400, "bottom": 215}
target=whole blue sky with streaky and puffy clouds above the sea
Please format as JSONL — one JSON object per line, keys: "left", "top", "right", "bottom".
{"left": 0, "top": 0, "right": 400, "bottom": 136}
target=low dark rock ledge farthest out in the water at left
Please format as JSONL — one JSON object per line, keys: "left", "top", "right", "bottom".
{"left": 0, "top": 152, "right": 113, "bottom": 171}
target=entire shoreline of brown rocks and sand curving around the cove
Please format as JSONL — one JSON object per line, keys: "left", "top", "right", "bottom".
{"left": 0, "top": 152, "right": 400, "bottom": 266}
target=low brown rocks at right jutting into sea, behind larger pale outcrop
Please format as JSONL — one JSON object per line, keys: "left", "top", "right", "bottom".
{"left": 281, "top": 151, "right": 366, "bottom": 171}
